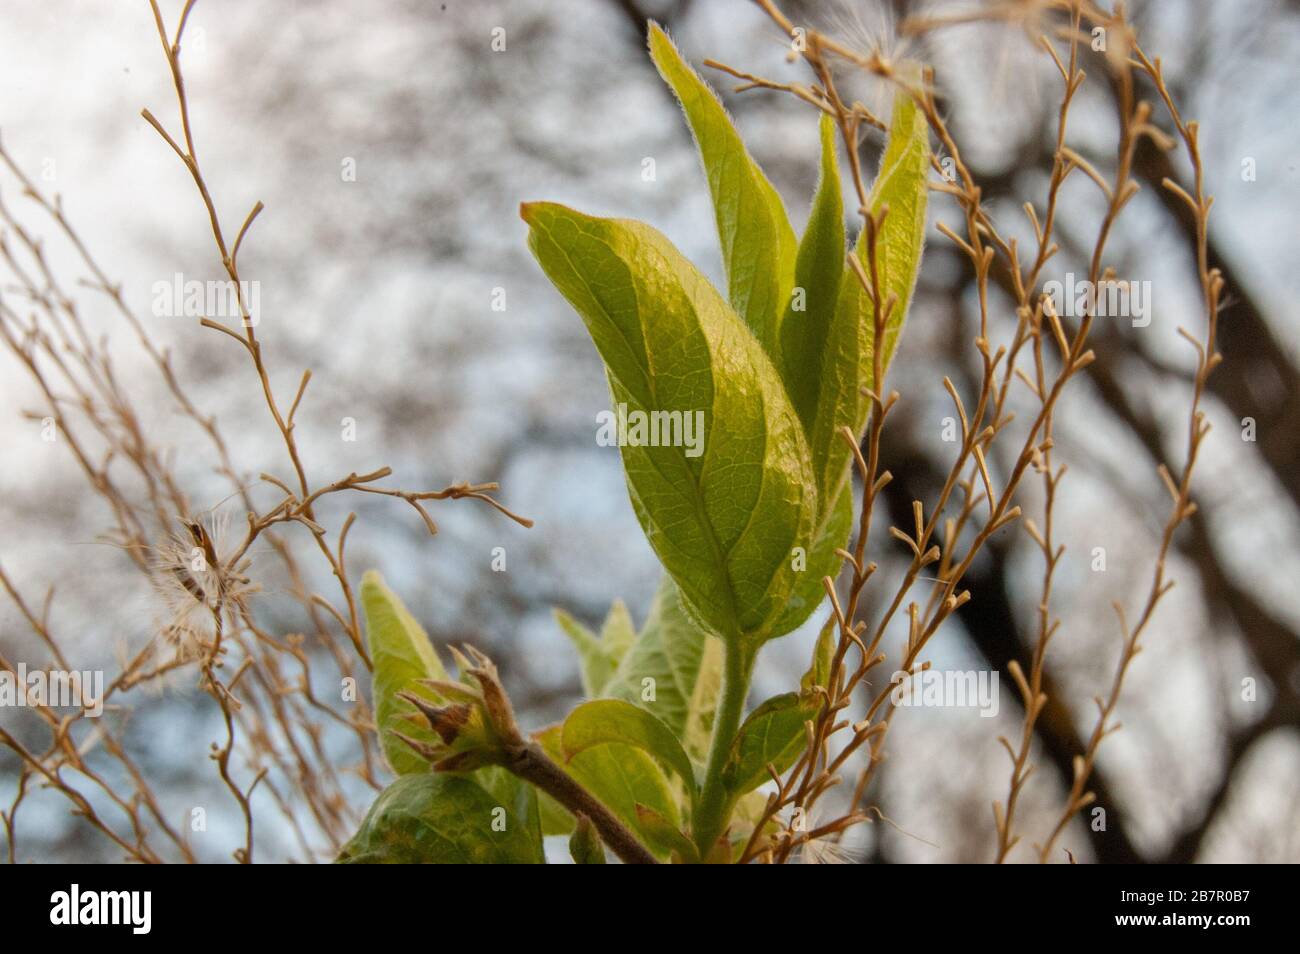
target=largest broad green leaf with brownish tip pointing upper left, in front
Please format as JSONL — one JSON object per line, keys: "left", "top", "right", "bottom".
{"left": 521, "top": 203, "right": 818, "bottom": 641}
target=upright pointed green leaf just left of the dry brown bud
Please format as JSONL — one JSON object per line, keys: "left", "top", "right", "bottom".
{"left": 361, "top": 571, "right": 447, "bottom": 775}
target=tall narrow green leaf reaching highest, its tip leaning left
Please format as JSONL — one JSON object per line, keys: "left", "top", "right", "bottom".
{"left": 650, "top": 23, "right": 795, "bottom": 357}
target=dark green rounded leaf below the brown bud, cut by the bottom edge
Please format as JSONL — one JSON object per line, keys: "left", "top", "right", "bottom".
{"left": 338, "top": 772, "right": 545, "bottom": 864}
